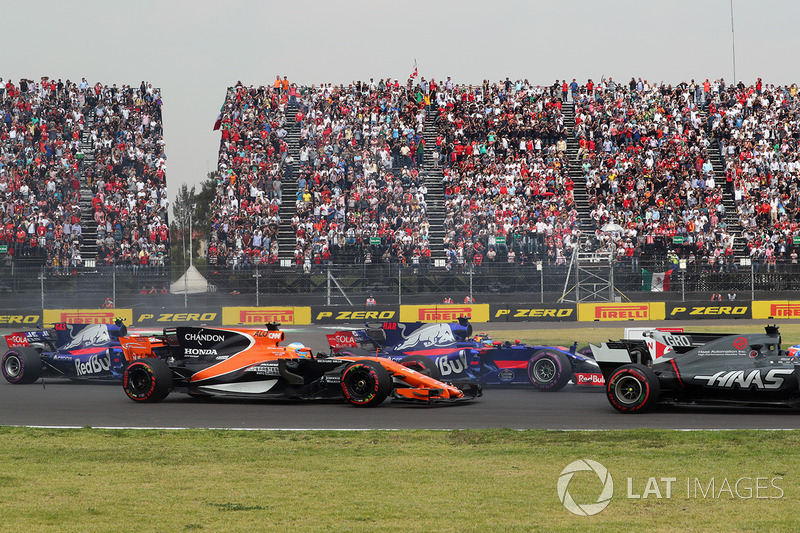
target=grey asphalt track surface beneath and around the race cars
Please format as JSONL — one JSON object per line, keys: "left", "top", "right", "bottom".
{"left": 0, "top": 321, "right": 800, "bottom": 430}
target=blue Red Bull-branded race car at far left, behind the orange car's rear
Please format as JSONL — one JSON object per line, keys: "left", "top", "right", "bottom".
{"left": 2, "top": 320, "right": 141, "bottom": 384}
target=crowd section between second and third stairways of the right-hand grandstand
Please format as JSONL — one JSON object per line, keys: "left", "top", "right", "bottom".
{"left": 435, "top": 78, "right": 578, "bottom": 266}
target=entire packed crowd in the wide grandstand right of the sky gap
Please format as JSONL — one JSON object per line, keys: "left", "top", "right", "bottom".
{"left": 209, "top": 78, "right": 800, "bottom": 270}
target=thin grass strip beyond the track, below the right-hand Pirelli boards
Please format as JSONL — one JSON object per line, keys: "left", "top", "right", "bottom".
{"left": 482, "top": 322, "right": 800, "bottom": 349}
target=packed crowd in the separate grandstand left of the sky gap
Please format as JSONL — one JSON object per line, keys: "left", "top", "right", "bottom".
{"left": 0, "top": 77, "right": 169, "bottom": 273}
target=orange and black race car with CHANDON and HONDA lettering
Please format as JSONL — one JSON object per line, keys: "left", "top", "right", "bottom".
{"left": 120, "top": 324, "right": 481, "bottom": 407}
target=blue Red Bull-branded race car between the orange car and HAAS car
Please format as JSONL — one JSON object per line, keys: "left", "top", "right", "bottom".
{"left": 327, "top": 319, "right": 603, "bottom": 391}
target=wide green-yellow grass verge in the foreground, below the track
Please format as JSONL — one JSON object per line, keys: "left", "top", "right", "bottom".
{"left": 0, "top": 428, "right": 800, "bottom": 532}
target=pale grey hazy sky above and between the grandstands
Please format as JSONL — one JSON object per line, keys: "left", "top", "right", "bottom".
{"left": 0, "top": 0, "right": 800, "bottom": 206}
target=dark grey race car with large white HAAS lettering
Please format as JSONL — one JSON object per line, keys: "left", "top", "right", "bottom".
{"left": 592, "top": 326, "right": 800, "bottom": 413}
